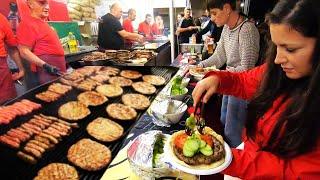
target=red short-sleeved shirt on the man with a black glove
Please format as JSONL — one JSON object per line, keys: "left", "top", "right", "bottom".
{"left": 17, "top": 17, "right": 64, "bottom": 56}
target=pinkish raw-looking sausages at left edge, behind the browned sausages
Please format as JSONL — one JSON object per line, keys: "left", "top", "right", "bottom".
{"left": 0, "top": 99, "right": 41, "bottom": 125}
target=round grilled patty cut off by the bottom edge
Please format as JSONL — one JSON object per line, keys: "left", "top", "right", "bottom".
{"left": 34, "top": 163, "right": 79, "bottom": 180}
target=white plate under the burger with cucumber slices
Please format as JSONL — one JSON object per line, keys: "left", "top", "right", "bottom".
{"left": 164, "top": 136, "right": 232, "bottom": 175}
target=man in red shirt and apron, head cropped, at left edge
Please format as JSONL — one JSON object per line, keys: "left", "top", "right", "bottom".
{"left": 0, "top": 14, "right": 24, "bottom": 104}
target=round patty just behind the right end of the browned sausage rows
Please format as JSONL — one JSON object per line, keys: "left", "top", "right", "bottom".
{"left": 58, "top": 101, "right": 91, "bottom": 121}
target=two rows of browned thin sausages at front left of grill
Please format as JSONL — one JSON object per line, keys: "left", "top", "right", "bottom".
{"left": 0, "top": 114, "right": 78, "bottom": 164}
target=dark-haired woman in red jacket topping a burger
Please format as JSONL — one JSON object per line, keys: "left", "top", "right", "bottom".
{"left": 192, "top": 0, "right": 320, "bottom": 179}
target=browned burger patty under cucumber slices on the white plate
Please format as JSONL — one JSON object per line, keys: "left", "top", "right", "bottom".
{"left": 173, "top": 137, "right": 225, "bottom": 165}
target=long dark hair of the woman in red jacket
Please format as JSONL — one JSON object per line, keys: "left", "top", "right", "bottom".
{"left": 246, "top": 0, "right": 320, "bottom": 158}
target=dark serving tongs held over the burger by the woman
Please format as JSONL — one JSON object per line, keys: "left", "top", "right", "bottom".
{"left": 185, "top": 96, "right": 206, "bottom": 136}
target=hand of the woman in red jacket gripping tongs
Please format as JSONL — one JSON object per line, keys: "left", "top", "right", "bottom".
{"left": 192, "top": 76, "right": 220, "bottom": 106}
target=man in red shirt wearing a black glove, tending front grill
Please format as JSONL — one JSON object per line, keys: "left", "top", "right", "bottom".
{"left": 17, "top": 0, "right": 66, "bottom": 86}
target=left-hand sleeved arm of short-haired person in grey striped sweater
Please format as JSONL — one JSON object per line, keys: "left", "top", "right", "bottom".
{"left": 199, "top": 27, "right": 227, "bottom": 69}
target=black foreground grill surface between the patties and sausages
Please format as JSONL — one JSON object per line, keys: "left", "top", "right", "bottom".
{"left": 0, "top": 66, "right": 178, "bottom": 180}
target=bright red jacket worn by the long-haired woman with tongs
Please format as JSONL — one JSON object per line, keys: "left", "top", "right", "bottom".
{"left": 206, "top": 65, "right": 320, "bottom": 179}
